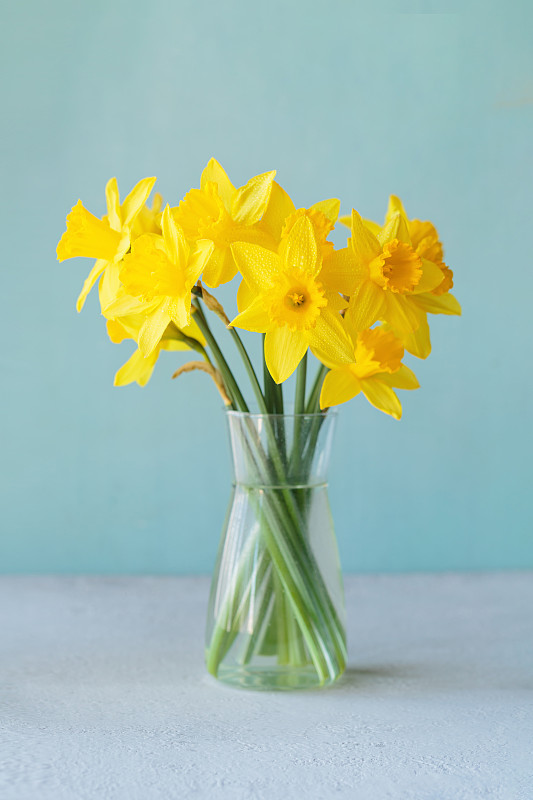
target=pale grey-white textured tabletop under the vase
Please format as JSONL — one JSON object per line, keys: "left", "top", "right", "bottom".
{"left": 0, "top": 573, "right": 533, "bottom": 800}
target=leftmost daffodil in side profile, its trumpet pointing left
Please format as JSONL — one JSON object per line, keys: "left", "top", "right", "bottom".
{"left": 57, "top": 178, "right": 156, "bottom": 311}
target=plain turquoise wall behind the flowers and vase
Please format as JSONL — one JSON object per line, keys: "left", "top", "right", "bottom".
{"left": 0, "top": 0, "right": 533, "bottom": 573}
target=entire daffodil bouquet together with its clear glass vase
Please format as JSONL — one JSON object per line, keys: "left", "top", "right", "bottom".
{"left": 57, "top": 159, "right": 461, "bottom": 688}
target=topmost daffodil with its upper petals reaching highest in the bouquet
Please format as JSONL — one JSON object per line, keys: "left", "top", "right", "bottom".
{"left": 172, "top": 158, "right": 276, "bottom": 287}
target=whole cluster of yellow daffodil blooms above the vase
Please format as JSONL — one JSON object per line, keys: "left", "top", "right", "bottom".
{"left": 57, "top": 159, "right": 461, "bottom": 419}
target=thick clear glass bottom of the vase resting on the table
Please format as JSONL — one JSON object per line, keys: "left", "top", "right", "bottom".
{"left": 210, "top": 664, "right": 341, "bottom": 692}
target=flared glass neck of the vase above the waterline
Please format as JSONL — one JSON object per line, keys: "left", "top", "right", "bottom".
{"left": 227, "top": 411, "right": 336, "bottom": 488}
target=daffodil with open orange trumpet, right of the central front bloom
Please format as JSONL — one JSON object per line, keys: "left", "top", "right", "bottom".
{"left": 327, "top": 210, "right": 443, "bottom": 346}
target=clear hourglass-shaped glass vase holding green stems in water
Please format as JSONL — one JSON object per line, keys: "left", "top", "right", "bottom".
{"left": 206, "top": 411, "right": 346, "bottom": 689}
